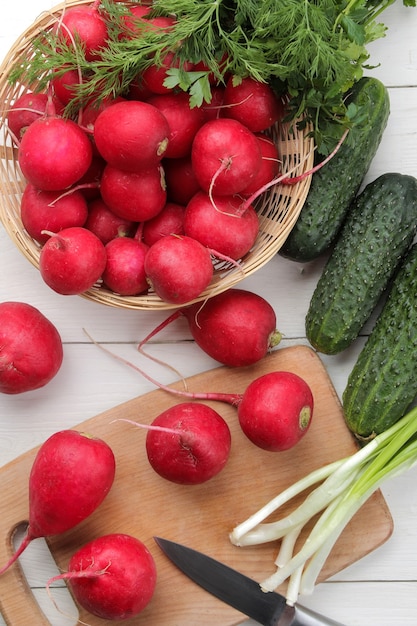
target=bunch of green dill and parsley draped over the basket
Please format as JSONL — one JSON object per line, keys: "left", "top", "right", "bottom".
{"left": 11, "top": 0, "right": 416, "bottom": 154}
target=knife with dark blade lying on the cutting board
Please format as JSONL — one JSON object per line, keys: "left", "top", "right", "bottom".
{"left": 154, "top": 537, "right": 343, "bottom": 626}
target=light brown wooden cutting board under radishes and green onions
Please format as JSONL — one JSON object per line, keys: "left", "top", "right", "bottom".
{"left": 0, "top": 346, "right": 393, "bottom": 626}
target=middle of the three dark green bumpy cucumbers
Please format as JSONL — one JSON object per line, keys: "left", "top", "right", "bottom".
{"left": 306, "top": 173, "right": 417, "bottom": 354}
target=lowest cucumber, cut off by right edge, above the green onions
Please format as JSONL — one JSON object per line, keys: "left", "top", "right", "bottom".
{"left": 342, "top": 244, "right": 417, "bottom": 441}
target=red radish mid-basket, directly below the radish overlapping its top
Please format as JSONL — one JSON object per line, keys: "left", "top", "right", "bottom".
{"left": 100, "top": 165, "right": 167, "bottom": 222}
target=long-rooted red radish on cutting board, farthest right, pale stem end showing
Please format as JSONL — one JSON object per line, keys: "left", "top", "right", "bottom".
{"left": 85, "top": 334, "right": 314, "bottom": 452}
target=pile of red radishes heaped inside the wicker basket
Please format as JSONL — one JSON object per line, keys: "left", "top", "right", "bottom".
{"left": 8, "top": 2, "right": 283, "bottom": 305}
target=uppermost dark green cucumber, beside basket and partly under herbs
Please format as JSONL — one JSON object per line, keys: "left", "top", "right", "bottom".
{"left": 279, "top": 77, "right": 390, "bottom": 263}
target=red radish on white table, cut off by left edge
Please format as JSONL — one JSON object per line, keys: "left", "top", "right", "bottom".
{"left": 0, "top": 302, "right": 63, "bottom": 394}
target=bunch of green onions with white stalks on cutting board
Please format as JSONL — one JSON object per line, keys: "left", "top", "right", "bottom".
{"left": 230, "top": 407, "right": 417, "bottom": 604}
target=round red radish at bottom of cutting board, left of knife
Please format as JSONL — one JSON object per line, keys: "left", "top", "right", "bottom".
{"left": 47, "top": 533, "right": 157, "bottom": 620}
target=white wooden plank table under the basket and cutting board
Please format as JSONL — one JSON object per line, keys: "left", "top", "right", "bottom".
{"left": 0, "top": 0, "right": 417, "bottom": 626}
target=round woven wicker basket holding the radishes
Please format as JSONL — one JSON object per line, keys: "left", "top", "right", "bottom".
{"left": 0, "top": 0, "right": 314, "bottom": 309}
